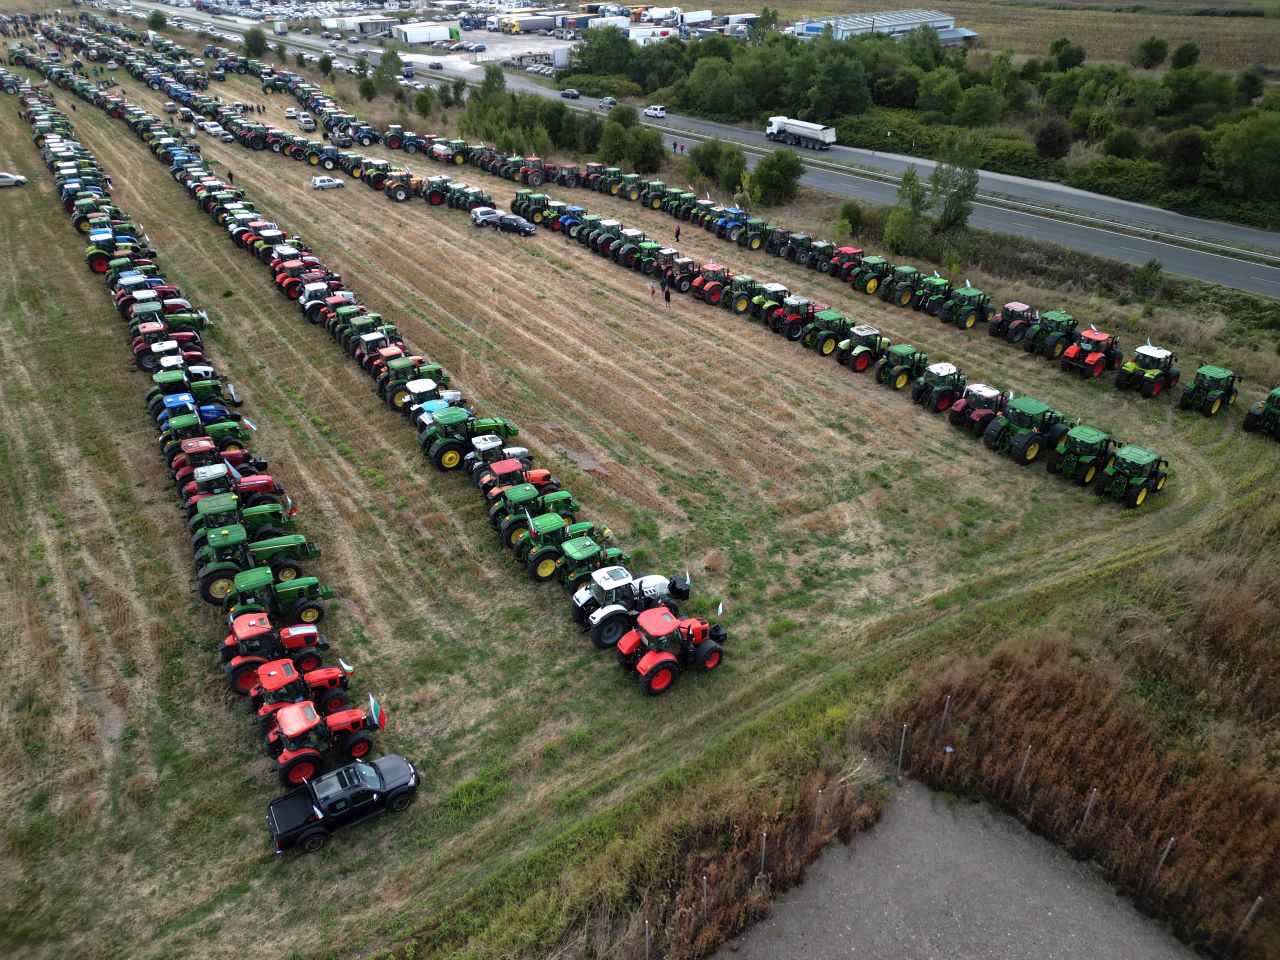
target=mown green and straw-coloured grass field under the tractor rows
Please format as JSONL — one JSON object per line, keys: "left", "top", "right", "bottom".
{"left": 0, "top": 58, "right": 1280, "bottom": 957}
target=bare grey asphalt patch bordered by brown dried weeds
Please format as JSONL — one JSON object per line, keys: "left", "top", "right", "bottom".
{"left": 713, "top": 783, "right": 1196, "bottom": 960}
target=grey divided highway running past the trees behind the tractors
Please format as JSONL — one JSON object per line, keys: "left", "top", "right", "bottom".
{"left": 124, "top": 0, "right": 1280, "bottom": 297}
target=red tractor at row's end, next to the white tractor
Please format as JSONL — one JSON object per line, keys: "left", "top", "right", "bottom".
{"left": 617, "top": 607, "right": 724, "bottom": 696}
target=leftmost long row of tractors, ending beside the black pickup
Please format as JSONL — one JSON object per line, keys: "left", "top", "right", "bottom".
{"left": 12, "top": 74, "right": 387, "bottom": 785}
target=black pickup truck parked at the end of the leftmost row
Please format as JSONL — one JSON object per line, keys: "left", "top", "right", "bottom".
{"left": 266, "top": 754, "right": 419, "bottom": 854}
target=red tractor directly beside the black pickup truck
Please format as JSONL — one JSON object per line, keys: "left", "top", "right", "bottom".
{"left": 262, "top": 696, "right": 387, "bottom": 787}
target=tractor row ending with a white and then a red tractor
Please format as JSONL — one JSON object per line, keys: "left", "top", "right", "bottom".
{"left": 22, "top": 48, "right": 724, "bottom": 695}
